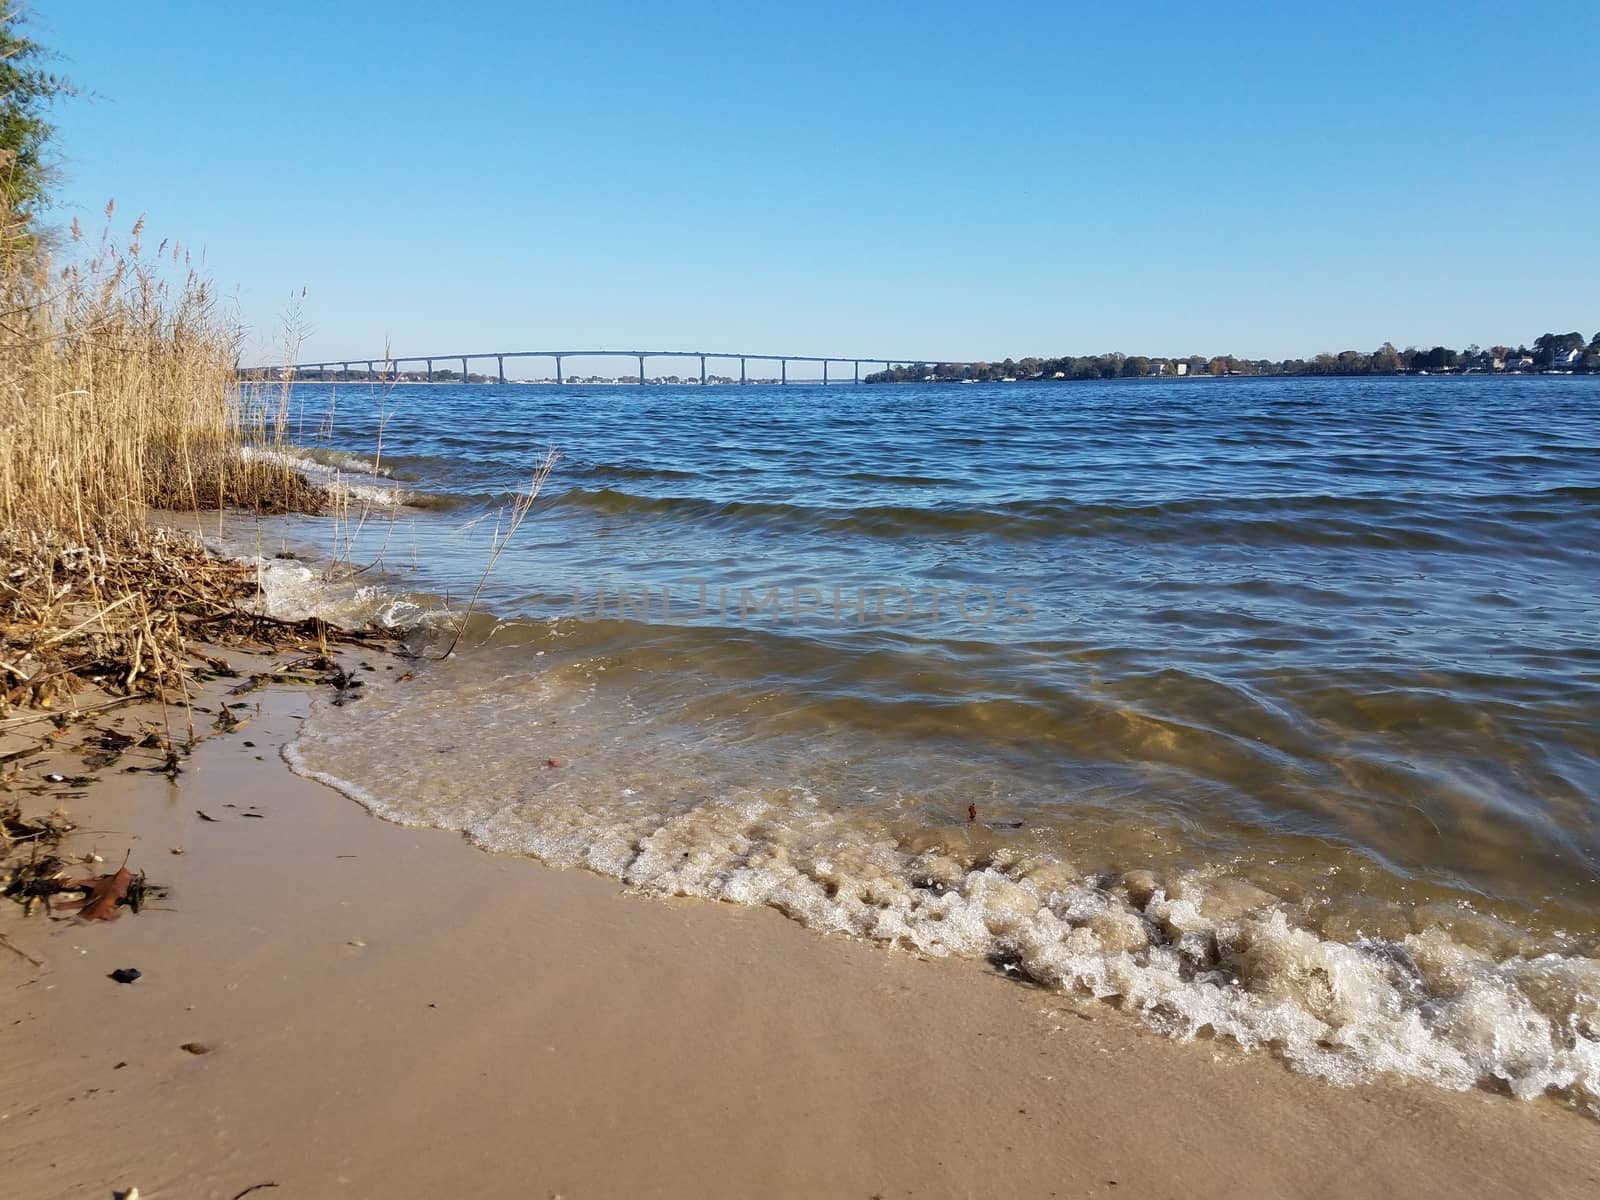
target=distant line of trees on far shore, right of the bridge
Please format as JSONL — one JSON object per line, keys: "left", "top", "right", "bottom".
{"left": 866, "top": 331, "right": 1600, "bottom": 384}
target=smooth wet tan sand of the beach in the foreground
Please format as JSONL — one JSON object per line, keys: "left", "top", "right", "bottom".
{"left": 0, "top": 691, "right": 1600, "bottom": 1200}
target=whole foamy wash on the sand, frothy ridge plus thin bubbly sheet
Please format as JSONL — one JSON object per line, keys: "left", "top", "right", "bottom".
{"left": 286, "top": 670, "right": 1600, "bottom": 1115}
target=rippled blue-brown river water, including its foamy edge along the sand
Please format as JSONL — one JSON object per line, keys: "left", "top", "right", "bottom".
{"left": 240, "top": 378, "right": 1600, "bottom": 1102}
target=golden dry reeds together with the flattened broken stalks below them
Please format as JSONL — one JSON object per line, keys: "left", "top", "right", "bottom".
{"left": 0, "top": 206, "right": 325, "bottom": 715}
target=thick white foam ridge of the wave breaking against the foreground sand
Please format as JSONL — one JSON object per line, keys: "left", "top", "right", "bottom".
{"left": 283, "top": 723, "right": 1600, "bottom": 1117}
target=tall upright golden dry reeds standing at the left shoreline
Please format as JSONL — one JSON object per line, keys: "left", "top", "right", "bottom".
{"left": 0, "top": 208, "right": 320, "bottom": 544}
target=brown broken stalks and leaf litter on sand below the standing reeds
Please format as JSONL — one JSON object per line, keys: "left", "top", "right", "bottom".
{"left": 0, "top": 533, "right": 412, "bottom": 947}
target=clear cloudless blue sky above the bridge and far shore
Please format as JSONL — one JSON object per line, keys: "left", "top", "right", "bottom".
{"left": 32, "top": 0, "right": 1600, "bottom": 366}
